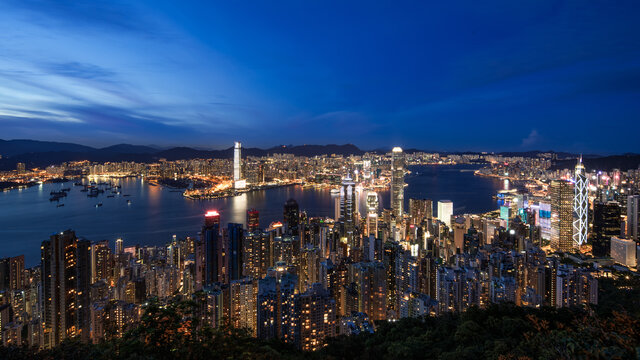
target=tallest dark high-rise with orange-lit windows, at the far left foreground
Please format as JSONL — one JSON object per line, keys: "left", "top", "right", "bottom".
{"left": 41, "top": 230, "right": 91, "bottom": 348}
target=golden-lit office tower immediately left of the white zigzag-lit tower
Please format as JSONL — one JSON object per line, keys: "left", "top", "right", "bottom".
{"left": 549, "top": 180, "right": 574, "bottom": 251}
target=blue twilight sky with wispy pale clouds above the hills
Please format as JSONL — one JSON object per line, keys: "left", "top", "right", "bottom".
{"left": 0, "top": 0, "right": 640, "bottom": 153}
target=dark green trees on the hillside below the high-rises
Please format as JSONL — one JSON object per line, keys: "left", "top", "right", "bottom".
{"left": 5, "top": 278, "right": 640, "bottom": 360}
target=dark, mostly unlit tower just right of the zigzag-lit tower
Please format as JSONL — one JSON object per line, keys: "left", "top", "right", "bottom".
{"left": 590, "top": 201, "right": 622, "bottom": 257}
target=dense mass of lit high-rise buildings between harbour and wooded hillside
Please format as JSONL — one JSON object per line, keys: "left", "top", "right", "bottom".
{"left": 5, "top": 144, "right": 640, "bottom": 351}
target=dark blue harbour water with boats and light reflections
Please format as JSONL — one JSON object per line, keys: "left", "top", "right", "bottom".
{"left": 0, "top": 165, "right": 503, "bottom": 266}
